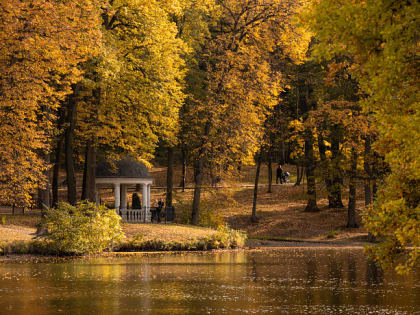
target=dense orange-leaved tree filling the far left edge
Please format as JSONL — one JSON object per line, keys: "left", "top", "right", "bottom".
{"left": 0, "top": 0, "right": 101, "bottom": 210}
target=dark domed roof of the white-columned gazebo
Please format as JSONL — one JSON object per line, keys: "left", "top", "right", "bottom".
{"left": 96, "top": 158, "right": 152, "bottom": 178}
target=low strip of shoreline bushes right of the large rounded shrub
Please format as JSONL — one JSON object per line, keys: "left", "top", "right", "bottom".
{"left": 116, "top": 226, "right": 247, "bottom": 251}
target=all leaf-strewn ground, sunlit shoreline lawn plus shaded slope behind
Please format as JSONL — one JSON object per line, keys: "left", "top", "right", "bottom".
{"left": 0, "top": 165, "right": 367, "bottom": 247}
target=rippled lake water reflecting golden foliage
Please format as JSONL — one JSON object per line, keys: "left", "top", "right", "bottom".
{"left": 0, "top": 248, "right": 420, "bottom": 315}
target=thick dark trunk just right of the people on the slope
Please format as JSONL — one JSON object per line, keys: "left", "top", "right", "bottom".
{"left": 305, "top": 130, "right": 319, "bottom": 212}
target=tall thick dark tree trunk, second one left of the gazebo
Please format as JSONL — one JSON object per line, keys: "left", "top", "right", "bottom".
{"left": 65, "top": 92, "right": 77, "bottom": 205}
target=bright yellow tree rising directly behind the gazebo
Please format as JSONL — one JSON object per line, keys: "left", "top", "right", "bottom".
{"left": 57, "top": 0, "right": 184, "bottom": 200}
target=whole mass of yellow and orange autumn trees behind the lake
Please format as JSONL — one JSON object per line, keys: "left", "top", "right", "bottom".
{"left": 0, "top": 0, "right": 420, "bottom": 271}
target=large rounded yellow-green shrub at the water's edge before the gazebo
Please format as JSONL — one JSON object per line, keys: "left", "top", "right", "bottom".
{"left": 42, "top": 201, "right": 124, "bottom": 255}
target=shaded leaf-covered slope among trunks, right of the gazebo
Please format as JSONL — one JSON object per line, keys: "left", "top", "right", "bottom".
{"left": 152, "top": 165, "right": 367, "bottom": 242}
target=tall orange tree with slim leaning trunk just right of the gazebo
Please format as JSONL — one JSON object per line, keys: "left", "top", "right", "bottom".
{"left": 179, "top": 0, "right": 310, "bottom": 224}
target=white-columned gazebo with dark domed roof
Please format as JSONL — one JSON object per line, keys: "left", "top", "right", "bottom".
{"left": 96, "top": 158, "right": 153, "bottom": 222}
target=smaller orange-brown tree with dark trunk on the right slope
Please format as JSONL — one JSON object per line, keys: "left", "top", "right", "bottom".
{"left": 312, "top": 59, "right": 362, "bottom": 215}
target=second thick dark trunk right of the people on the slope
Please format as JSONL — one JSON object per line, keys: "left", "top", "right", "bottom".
{"left": 331, "top": 135, "right": 344, "bottom": 208}
